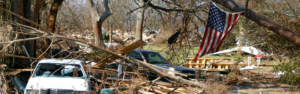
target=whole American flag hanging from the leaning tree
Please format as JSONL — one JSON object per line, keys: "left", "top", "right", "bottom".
{"left": 194, "top": 2, "right": 243, "bottom": 61}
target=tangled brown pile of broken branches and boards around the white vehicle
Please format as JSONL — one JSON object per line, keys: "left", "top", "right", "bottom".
{"left": 0, "top": 8, "right": 228, "bottom": 94}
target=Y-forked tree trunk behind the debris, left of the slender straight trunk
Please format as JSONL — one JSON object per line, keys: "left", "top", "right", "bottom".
{"left": 87, "top": 0, "right": 111, "bottom": 48}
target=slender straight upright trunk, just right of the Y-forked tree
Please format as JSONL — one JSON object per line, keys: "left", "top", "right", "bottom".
{"left": 135, "top": 0, "right": 145, "bottom": 40}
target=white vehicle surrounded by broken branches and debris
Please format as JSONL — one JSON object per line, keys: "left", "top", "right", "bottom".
{"left": 24, "top": 59, "right": 90, "bottom": 94}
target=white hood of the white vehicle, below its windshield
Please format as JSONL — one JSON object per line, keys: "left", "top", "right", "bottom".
{"left": 26, "top": 77, "right": 88, "bottom": 91}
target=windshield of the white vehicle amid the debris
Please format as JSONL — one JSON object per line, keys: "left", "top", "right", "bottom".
{"left": 34, "top": 63, "right": 85, "bottom": 79}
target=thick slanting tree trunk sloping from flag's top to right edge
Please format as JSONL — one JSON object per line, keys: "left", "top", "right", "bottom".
{"left": 212, "top": 0, "right": 300, "bottom": 46}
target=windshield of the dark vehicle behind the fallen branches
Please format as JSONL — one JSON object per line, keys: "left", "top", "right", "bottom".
{"left": 142, "top": 52, "right": 167, "bottom": 64}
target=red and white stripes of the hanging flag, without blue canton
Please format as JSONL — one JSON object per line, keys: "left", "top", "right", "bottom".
{"left": 194, "top": 12, "right": 243, "bottom": 61}
